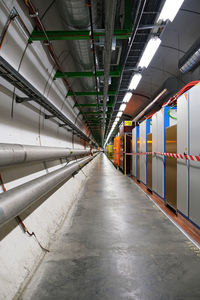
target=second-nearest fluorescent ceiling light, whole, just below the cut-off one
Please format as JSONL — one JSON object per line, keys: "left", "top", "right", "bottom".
{"left": 138, "top": 36, "right": 161, "bottom": 68}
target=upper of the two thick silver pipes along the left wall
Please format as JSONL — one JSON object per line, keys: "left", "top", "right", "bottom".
{"left": 0, "top": 143, "right": 90, "bottom": 167}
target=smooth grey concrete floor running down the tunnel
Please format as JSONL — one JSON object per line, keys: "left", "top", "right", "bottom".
{"left": 21, "top": 154, "right": 200, "bottom": 300}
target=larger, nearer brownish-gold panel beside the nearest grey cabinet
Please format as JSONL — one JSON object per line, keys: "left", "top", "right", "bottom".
{"left": 165, "top": 125, "right": 177, "bottom": 209}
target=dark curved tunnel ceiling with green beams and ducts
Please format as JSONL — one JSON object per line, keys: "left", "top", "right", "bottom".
{"left": 30, "top": 0, "right": 200, "bottom": 145}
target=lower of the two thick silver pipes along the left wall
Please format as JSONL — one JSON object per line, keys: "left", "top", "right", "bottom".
{"left": 0, "top": 156, "right": 97, "bottom": 226}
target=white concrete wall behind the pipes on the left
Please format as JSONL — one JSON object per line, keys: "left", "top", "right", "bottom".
{"left": 0, "top": 1, "right": 95, "bottom": 300}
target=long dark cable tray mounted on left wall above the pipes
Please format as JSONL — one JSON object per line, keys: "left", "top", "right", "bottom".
{"left": 0, "top": 56, "right": 95, "bottom": 144}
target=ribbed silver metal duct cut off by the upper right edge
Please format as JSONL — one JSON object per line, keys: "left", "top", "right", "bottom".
{"left": 178, "top": 38, "right": 200, "bottom": 73}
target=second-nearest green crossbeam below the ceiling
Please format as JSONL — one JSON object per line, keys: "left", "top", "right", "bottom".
{"left": 54, "top": 70, "right": 121, "bottom": 79}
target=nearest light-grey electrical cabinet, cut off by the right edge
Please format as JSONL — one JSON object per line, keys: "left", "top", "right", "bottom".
{"left": 177, "top": 84, "right": 200, "bottom": 226}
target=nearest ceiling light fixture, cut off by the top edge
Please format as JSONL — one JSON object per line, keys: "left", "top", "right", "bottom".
{"left": 158, "top": 0, "right": 184, "bottom": 22}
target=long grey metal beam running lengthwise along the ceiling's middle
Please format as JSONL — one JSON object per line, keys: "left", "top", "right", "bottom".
{"left": 102, "top": 0, "right": 117, "bottom": 144}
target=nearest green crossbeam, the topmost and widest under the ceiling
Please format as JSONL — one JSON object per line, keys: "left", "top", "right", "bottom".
{"left": 29, "top": 29, "right": 131, "bottom": 43}
